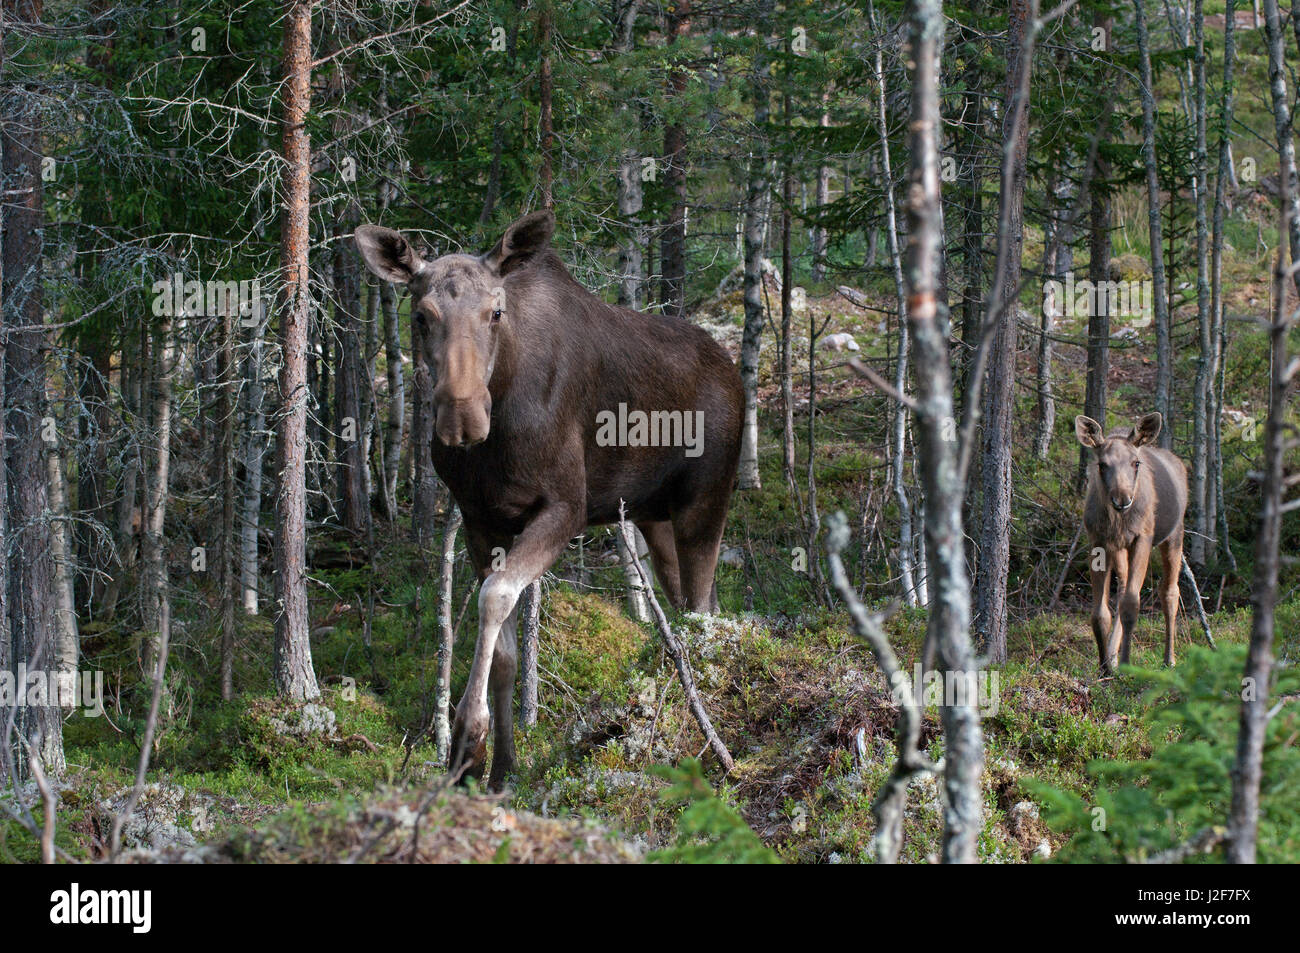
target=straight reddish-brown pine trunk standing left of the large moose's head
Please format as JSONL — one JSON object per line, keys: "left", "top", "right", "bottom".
{"left": 274, "top": 0, "right": 320, "bottom": 701}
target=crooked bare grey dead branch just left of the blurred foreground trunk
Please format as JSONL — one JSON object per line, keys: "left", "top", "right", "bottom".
{"left": 826, "top": 511, "right": 940, "bottom": 863}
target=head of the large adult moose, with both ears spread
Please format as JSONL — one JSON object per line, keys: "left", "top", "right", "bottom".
{"left": 355, "top": 209, "right": 555, "bottom": 447}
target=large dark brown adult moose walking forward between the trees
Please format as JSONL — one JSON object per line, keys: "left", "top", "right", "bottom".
{"left": 355, "top": 211, "right": 744, "bottom": 789}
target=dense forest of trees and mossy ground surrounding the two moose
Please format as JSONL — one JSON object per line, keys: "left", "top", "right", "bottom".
{"left": 0, "top": 0, "right": 1300, "bottom": 861}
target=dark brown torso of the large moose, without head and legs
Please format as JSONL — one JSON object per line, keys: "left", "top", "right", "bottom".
{"left": 433, "top": 252, "right": 744, "bottom": 533}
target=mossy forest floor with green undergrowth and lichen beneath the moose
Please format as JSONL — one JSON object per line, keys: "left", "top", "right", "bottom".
{"left": 0, "top": 256, "right": 1300, "bottom": 862}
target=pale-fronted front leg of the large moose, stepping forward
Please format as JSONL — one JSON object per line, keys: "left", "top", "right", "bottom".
{"left": 447, "top": 497, "right": 586, "bottom": 779}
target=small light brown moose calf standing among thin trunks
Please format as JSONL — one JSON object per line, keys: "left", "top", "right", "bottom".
{"left": 1074, "top": 413, "right": 1187, "bottom": 675}
